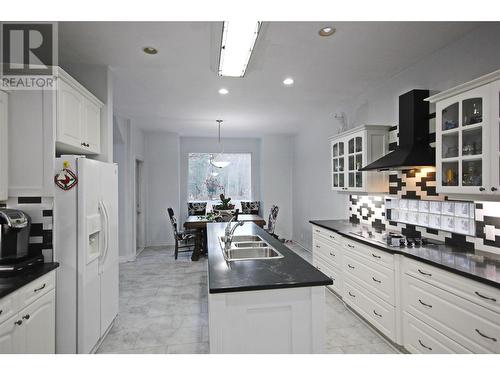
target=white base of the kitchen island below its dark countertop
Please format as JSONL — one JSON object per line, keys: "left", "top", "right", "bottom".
{"left": 208, "top": 286, "right": 325, "bottom": 354}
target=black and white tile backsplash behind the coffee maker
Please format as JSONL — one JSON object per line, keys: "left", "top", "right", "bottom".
{"left": 0, "top": 197, "right": 54, "bottom": 262}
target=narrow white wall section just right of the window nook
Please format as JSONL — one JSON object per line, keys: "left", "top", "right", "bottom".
{"left": 260, "top": 135, "right": 293, "bottom": 239}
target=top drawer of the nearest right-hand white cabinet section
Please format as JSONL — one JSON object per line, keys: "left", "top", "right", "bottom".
{"left": 403, "top": 257, "right": 500, "bottom": 313}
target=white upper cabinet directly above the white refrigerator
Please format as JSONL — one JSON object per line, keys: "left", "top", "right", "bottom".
{"left": 56, "top": 70, "right": 103, "bottom": 154}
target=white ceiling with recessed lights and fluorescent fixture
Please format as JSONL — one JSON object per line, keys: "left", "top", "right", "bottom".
{"left": 59, "top": 22, "right": 477, "bottom": 137}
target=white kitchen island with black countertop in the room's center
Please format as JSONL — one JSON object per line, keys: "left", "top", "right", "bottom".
{"left": 207, "top": 223, "right": 332, "bottom": 354}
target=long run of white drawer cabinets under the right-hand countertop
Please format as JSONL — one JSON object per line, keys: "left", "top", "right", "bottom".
{"left": 313, "top": 225, "right": 500, "bottom": 354}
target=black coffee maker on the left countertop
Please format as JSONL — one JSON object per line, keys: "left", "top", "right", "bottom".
{"left": 0, "top": 208, "right": 31, "bottom": 264}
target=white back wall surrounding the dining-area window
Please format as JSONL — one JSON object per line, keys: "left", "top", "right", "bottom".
{"left": 179, "top": 137, "right": 261, "bottom": 226}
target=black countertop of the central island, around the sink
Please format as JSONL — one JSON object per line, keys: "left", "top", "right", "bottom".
{"left": 207, "top": 223, "right": 332, "bottom": 293}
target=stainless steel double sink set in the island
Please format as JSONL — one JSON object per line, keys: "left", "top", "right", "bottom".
{"left": 219, "top": 235, "right": 283, "bottom": 262}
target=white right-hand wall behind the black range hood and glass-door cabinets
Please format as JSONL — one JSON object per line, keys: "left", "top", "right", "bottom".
{"left": 293, "top": 23, "right": 500, "bottom": 249}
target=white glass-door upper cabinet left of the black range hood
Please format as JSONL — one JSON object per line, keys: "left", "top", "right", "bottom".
{"left": 330, "top": 125, "right": 390, "bottom": 193}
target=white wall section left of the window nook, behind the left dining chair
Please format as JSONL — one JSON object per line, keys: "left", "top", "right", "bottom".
{"left": 144, "top": 132, "right": 180, "bottom": 246}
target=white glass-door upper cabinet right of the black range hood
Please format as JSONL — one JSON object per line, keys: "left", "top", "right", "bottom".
{"left": 429, "top": 71, "right": 500, "bottom": 195}
